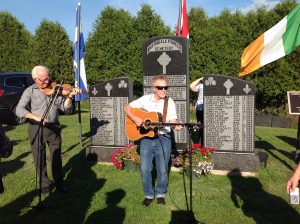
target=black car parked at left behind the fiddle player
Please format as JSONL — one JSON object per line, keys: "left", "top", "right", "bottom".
{"left": 0, "top": 72, "right": 34, "bottom": 125}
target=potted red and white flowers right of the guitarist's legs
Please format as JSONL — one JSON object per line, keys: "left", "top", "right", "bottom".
{"left": 175, "top": 144, "right": 215, "bottom": 177}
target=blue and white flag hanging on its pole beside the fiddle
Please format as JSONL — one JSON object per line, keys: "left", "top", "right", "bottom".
{"left": 74, "top": 3, "right": 88, "bottom": 101}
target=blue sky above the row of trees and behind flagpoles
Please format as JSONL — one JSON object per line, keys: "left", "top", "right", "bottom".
{"left": 0, "top": 0, "right": 290, "bottom": 40}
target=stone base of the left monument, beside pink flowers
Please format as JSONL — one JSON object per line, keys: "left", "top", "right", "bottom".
{"left": 86, "top": 146, "right": 122, "bottom": 163}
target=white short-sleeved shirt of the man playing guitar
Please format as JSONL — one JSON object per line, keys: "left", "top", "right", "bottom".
{"left": 130, "top": 94, "right": 177, "bottom": 132}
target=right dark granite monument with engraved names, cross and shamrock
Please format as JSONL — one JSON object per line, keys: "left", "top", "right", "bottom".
{"left": 203, "top": 75, "right": 259, "bottom": 172}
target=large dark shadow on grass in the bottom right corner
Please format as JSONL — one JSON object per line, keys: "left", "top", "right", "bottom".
{"left": 228, "top": 170, "right": 300, "bottom": 224}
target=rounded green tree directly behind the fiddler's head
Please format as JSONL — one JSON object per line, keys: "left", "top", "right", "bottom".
{"left": 31, "top": 20, "right": 74, "bottom": 83}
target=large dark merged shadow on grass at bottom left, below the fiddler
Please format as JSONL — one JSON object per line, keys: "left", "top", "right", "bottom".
{"left": 0, "top": 150, "right": 106, "bottom": 224}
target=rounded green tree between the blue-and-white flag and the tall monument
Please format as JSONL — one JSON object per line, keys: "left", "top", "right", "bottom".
{"left": 85, "top": 7, "right": 134, "bottom": 84}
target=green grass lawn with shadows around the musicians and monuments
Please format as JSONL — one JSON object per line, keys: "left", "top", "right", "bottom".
{"left": 0, "top": 111, "right": 300, "bottom": 224}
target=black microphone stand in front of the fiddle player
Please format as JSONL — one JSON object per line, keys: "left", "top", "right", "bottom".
{"left": 31, "top": 86, "right": 61, "bottom": 209}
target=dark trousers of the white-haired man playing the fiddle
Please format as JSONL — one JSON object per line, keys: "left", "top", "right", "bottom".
{"left": 28, "top": 124, "right": 63, "bottom": 187}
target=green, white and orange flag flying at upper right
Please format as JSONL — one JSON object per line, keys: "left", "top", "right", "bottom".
{"left": 239, "top": 5, "right": 300, "bottom": 77}
